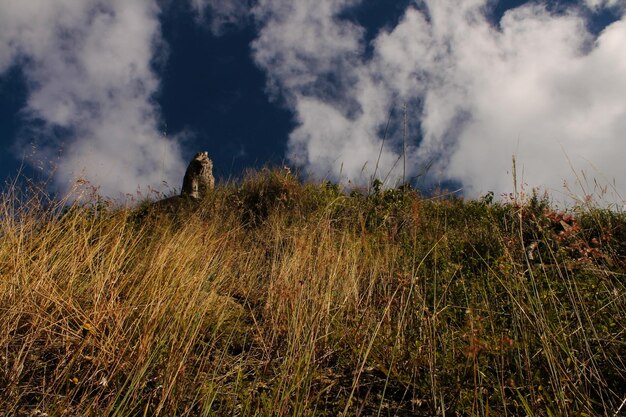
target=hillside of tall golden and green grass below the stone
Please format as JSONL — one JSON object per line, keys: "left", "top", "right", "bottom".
{"left": 0, "top": 170, "right": 626, "bottom": 416}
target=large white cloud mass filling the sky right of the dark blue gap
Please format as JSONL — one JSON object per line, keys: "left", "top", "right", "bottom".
{"left": 253, "top": 0, "right": 626, "bottom": 202}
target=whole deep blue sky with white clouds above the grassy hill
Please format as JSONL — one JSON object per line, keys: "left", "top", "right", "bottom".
{"left": 0, "top": 0, "right": 626, "bottom": 205}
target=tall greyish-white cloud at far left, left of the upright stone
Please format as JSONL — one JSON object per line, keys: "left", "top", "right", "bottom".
{"left": 0, "top": 0, "right": 184, "bottom": 196}
